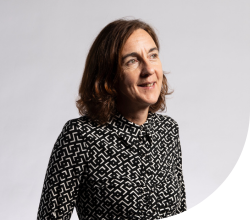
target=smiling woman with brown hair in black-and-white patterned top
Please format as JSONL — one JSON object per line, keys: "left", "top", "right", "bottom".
{"left": 37, "top": 20, "right": 186, "bottom": 220}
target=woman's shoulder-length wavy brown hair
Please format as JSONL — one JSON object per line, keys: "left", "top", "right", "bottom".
{"left": 76, "top": 19, "right": 173, "bottom": 124}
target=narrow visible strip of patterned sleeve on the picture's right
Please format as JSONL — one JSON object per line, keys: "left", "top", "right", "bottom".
{"left": 175, "top": 124, "right": 187, "bottom": 213}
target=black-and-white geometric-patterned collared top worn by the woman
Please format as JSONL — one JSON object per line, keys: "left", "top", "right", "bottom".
{"left": 37, "top": 113, "right": 186, "bottom": 220}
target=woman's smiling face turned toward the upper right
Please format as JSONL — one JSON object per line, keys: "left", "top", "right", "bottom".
{"left": 118, "top": 29, "right": 163, "bottom": 111}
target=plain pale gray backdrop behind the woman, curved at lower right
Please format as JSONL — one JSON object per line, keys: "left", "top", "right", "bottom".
{"left": 0, "top": 0, "right": 250, "bottom": 220}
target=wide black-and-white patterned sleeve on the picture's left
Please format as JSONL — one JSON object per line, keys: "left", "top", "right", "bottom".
{"left": 37, "top": 120, "right": 86, "bottom": 220}
